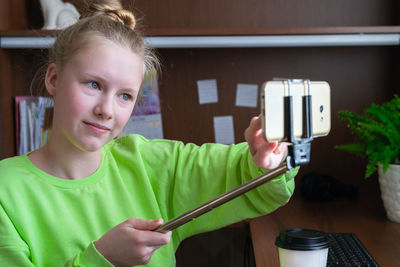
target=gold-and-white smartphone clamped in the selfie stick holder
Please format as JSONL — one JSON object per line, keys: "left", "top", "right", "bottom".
{"left": 260, "top": 80, "right": 331, "bottom": 142}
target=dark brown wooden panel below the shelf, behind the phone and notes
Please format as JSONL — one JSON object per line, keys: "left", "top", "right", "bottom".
{"left": 160, "top": 47, "right": 398, "bottom": 187}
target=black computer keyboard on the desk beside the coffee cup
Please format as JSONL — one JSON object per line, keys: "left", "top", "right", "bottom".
{"left": 327, "top": 233, "right": 379, "bottom": 267}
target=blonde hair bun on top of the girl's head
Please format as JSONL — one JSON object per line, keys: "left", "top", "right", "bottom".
{"left": 81, "top": 0, "right": 136, "bottom": 30}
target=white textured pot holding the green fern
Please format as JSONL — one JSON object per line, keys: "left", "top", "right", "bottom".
{"left": 378, "top": 164, "right": 400, "bottom": 223}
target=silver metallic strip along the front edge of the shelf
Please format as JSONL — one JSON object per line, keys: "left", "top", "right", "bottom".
{"left": 0, "top": 33, "right": 400, "bottom": 49}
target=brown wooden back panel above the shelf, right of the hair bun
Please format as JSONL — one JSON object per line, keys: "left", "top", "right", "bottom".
{"left": 130, "top": 0, "right": 398, "bottom": 29}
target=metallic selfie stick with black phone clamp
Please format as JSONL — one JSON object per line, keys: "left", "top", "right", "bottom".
{"left": 154, "top": 79, "right": 313, "bottom": 233}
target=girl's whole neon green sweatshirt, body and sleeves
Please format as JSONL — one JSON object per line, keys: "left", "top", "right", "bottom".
{"left": 0, "top": 135, "right": 297, "bottom": 267}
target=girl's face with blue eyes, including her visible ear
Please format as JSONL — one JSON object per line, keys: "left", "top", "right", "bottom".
{"left": 46, "top": 41, "right": 144, "bottom": 152}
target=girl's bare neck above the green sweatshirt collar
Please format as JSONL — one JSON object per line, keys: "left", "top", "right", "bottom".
{"left": 29, "top": 138, "right": 102, "bottom": 180}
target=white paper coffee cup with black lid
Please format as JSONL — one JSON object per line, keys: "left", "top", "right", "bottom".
{"left": 275, "top": 228, "right": 329, "bottom": 267}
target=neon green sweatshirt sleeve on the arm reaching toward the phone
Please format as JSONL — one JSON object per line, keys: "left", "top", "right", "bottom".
{"left": 141, "top": 141, "right": 298, "bottom": 244}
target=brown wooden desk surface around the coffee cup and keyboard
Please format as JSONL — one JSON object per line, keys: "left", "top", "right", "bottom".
{"left": 250, "top": 184, "right": 400, "bottom": 267}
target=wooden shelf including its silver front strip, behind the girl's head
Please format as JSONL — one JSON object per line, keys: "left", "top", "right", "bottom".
{"left": 0, "top": 26, "right": 400, "bottom": 48}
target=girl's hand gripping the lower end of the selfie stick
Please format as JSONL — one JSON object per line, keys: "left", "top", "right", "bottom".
{"left": 94, "top": 219, "right": 171, "bottom": 266}
